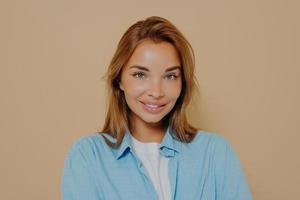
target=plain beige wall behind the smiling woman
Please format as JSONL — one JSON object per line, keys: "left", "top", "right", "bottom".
{"left": 0, "top": 0, "right": 300, "bottom": 200}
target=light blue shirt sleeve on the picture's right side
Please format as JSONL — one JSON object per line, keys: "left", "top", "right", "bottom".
{"left": 215, "top": 136, "right": 252, "bottom": 200}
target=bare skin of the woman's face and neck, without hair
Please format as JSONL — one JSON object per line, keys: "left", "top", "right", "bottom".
{"left": 120, "top": 40, "right": 182, "bottom": 143}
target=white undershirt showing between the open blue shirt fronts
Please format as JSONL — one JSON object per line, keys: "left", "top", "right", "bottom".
{"left": 131, "top": 136, "right": 171, "bottom": 200}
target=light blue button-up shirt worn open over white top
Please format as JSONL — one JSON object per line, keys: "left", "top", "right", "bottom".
{"left": 61, "top": 127, "right": 252, "bottom": 200}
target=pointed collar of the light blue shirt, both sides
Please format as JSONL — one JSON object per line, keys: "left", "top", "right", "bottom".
{"left": 114, "top": 126, "right": 181, "bottom": 160}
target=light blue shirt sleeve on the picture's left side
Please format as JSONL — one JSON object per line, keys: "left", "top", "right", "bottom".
{"left": 61, "top": 139, "right": 101, "bottom": 200}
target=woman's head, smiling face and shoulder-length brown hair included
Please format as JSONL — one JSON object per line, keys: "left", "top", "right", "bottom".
{"left": 101, "top": 16, "right": 196, "bottom": 147}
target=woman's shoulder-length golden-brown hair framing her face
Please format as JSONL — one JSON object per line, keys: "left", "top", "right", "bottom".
{"left": 99, "top": 16, "right": 197, "bottom": 148}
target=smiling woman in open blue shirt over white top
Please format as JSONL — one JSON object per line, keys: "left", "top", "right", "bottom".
{"left": 61, "top": 16, "right": 252, "bottom": 200}
